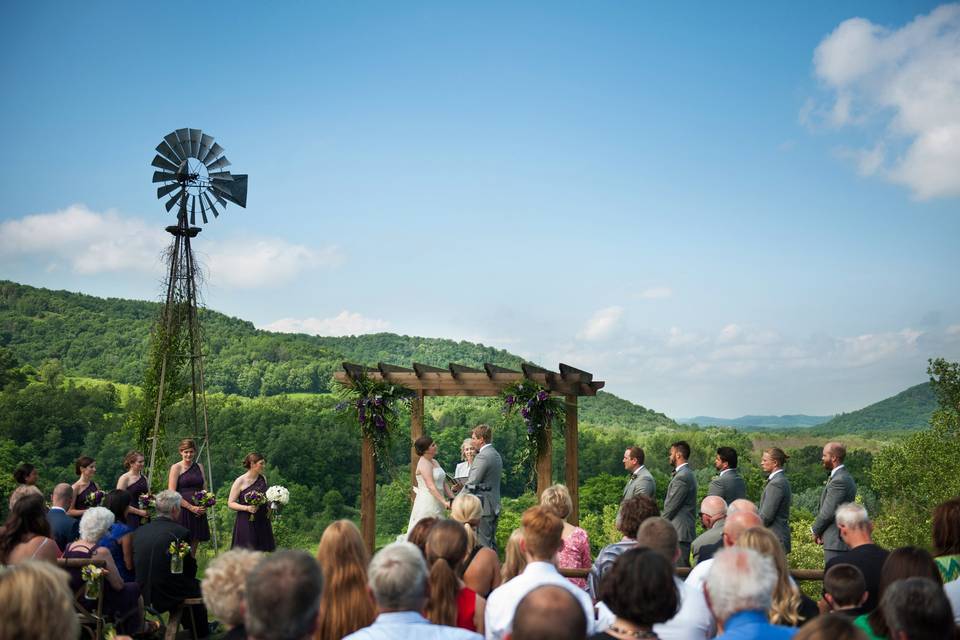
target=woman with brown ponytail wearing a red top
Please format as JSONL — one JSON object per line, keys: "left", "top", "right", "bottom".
{"left": 426, "top": 520, "right": 486, "bottom": 633}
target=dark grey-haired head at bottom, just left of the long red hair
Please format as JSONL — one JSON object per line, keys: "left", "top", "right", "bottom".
{"left": 244, "top": 549, "right": 323, "bottom": 640}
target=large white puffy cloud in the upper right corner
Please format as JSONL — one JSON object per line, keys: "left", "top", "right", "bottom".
{"left": 800, "top": 4, "right": 960, "bottom": 199}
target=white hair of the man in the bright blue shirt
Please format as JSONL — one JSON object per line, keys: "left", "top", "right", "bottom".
{"left": 705, "top": 547, "right": 777, "bottom": 622}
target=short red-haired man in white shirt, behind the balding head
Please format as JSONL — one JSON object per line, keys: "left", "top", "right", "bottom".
{"left": 484, "top": 508, "right": 596, "bottom": 640}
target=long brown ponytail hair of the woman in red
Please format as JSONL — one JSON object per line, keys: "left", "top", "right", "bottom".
{"left": 426, "top": 520, "right": 467, "bottom": 627}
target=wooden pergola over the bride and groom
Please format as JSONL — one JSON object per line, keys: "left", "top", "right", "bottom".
{"left": 335, "top": 362, "right": 604, "bottom": 552}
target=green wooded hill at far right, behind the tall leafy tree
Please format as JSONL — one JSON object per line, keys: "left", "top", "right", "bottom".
{"left": 814, "top": 382, "right": 937, "bottom": 434}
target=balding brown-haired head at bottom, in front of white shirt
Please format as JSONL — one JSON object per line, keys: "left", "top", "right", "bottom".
{"left": 510, "top": 585, "right": 587, "bottom": 640}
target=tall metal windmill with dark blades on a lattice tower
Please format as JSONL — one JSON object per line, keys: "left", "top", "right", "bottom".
{"left": 147, "top": 129, "right": 247, "bottom": 548}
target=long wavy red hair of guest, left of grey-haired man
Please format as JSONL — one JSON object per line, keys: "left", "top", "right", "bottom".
{"left": 314, "top": 520, "right": 377, "bottom": 640}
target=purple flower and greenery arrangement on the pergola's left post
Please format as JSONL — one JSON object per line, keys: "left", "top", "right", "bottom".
{"left": 337, "top": 375, "right": 415, "bottom": 467}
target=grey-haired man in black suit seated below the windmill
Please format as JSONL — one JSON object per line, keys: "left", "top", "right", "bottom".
{"left": 133, "top": 490, "right": 209, "bottom": 638}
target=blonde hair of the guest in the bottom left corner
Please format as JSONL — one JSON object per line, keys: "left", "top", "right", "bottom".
{"left": 0, "top": 560, "right": 80, "bottom": 640}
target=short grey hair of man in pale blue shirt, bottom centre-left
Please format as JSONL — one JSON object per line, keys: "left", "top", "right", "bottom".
{"left": 367, "top": 542, "right": 427, "bottom": 611}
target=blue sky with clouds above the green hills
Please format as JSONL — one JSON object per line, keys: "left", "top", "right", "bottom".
{"left": 0, "top": 0, "right": 960, "bottom": 418}
